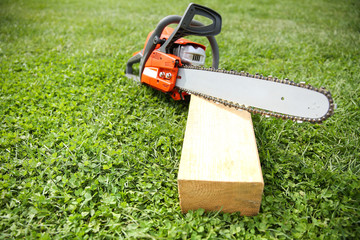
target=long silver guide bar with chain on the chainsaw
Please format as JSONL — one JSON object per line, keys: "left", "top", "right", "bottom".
{"left": 176, "top": 68, "right": 333, "bottom": 122}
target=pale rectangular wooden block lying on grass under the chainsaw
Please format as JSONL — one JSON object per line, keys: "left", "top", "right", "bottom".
{"left": 178, "top": 96, "right": 264, "bottom": 216}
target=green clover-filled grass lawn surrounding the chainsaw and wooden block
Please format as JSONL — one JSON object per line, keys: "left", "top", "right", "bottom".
{"left": 0, "top": 0, "right": 360, "bottom": 239}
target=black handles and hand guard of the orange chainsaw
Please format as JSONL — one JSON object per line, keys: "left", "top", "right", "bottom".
{"left": 126, "top": 3, "right": 221, "bottom": 79}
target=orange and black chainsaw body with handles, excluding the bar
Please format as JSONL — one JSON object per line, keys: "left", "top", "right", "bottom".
{"left": 126, "top": 4, "right": 221, "bottom": 100}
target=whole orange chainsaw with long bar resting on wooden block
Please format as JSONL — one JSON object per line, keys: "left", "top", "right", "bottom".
{"left": 126, "top": 3, "right": 336, "bottom": 123}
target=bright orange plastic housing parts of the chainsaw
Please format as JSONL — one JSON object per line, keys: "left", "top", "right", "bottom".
{"left": 141, "top": 27, "right": 206, "bottom": 100}
